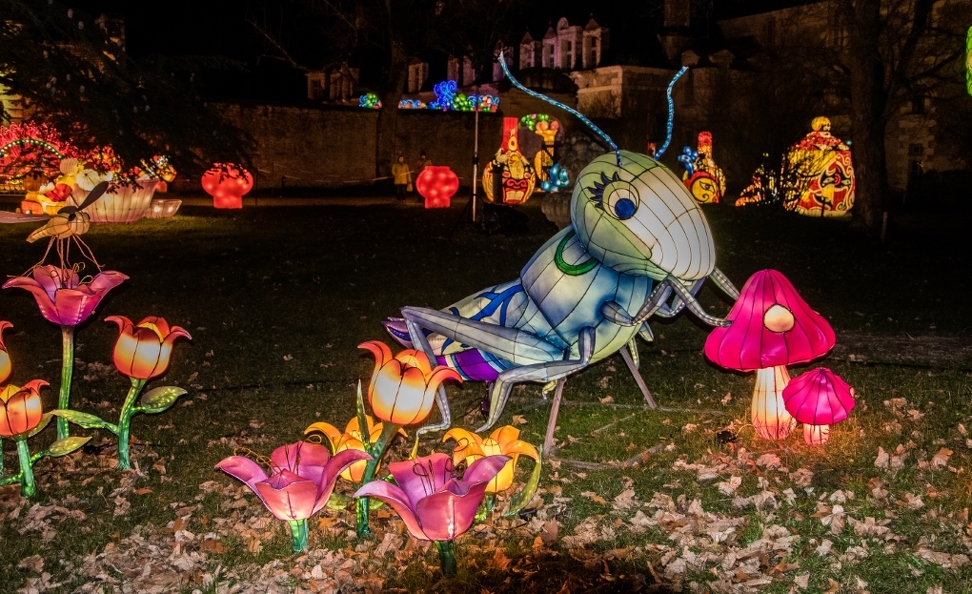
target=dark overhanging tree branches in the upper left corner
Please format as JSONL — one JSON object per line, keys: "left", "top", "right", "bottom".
{"left": 0, "top": 0, "right": 246, "bottom": 173}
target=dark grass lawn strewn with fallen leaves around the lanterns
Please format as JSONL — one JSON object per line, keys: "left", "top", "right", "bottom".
{"left": 0, "top": 195, "right": 972, "bottom": 594}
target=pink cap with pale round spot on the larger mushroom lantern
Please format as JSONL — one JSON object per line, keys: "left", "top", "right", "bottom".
{"left": 705, "top": 270, "right": 835, "bottom": 371}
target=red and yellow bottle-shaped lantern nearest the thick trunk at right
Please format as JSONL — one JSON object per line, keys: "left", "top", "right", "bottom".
{"left": 782, "top": 117, "right": 857, "bottom": 217}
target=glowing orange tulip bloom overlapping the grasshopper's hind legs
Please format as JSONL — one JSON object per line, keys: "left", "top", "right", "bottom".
{"left": 358, "top": 340, "right": 462, "bottom": 425}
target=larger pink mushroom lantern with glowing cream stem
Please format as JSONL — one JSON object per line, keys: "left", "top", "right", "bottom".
{"left": 705, "top": 270, "right": 835, "bottom": 439}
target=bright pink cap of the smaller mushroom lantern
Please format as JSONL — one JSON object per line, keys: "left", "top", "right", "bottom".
{"left": 783, "top": 367, "right": 855, "bottom": 425}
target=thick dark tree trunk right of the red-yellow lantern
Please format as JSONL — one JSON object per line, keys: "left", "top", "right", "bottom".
{"left": 847, "top": 0, "right": 888, "bottom": 236}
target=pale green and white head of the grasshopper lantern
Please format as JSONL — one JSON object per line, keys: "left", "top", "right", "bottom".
{"left": 571, "top": 151, "right": 715, "bottom": 281}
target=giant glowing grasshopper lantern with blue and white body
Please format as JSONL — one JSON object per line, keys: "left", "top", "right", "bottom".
{"left": 385, "top": 58, "right": 738, "bottom": 452}
